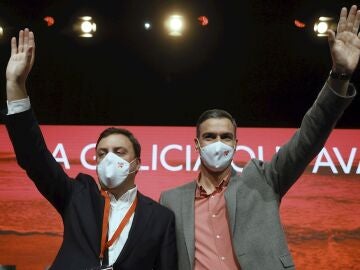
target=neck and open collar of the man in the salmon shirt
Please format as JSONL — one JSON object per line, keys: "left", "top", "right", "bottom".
{"left": 199, "top": 165, "right": 231, "bottom": 194}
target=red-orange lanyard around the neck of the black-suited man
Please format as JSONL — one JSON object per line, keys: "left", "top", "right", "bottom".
{"left": 99, "top": 190, "right": 138, "bottom": 260}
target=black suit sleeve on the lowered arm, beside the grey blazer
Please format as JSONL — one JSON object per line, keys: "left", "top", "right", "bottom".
{"left": 154, "top": 211, "right": 178, "bottom": 270}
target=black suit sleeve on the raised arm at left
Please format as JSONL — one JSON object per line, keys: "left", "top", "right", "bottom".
{"left": 4, "top": 110, "right": 73, "bottom": 214}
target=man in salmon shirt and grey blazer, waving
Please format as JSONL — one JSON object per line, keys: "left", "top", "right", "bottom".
{"left": 160, "top": 6, "right": 360, "bottom": 270}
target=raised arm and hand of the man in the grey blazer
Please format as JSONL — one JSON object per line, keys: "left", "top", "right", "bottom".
{"left": 264, "top": 6, "right": 360, "bottom": 198}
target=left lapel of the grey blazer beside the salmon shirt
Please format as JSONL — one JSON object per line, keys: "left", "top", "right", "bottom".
{"left": 181, "top": 182, "right": 196, "bottom": 262}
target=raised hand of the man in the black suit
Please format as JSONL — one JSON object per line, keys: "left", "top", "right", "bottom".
{"left": 6, "top": 28, "right": 35, "bottom": 100}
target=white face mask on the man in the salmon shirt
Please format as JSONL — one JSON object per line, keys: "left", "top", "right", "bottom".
{"left": 199, "top": 141, "right": 234, "bottom": 172}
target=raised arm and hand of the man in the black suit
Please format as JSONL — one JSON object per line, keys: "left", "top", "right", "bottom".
{"left": 5, "top": 29, "right": 71, "bottom": 213}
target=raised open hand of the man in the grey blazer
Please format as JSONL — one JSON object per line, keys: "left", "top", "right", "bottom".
{"left": 328, "top": 5, "right": 360, "bottom": 75}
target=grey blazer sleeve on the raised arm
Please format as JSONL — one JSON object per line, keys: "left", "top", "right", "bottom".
{"left": 264, "top": 80, "right": 356, "bottom": 199}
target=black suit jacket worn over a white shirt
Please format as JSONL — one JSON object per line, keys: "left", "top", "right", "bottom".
{"left": 5, "top": 110, "right": 177, "bottom": 270}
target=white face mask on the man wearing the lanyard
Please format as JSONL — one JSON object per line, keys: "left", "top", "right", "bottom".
{"left": 97, "top": 152, "right": 136, "bottom": 188}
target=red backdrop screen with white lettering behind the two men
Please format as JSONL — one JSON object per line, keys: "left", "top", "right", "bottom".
{"left": 0, "top": 125, "right": 360, "bottom": 270}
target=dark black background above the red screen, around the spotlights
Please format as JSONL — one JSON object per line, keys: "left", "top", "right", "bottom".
{"left": 0, "top": 0, "right": 360, "bottom": 128}
